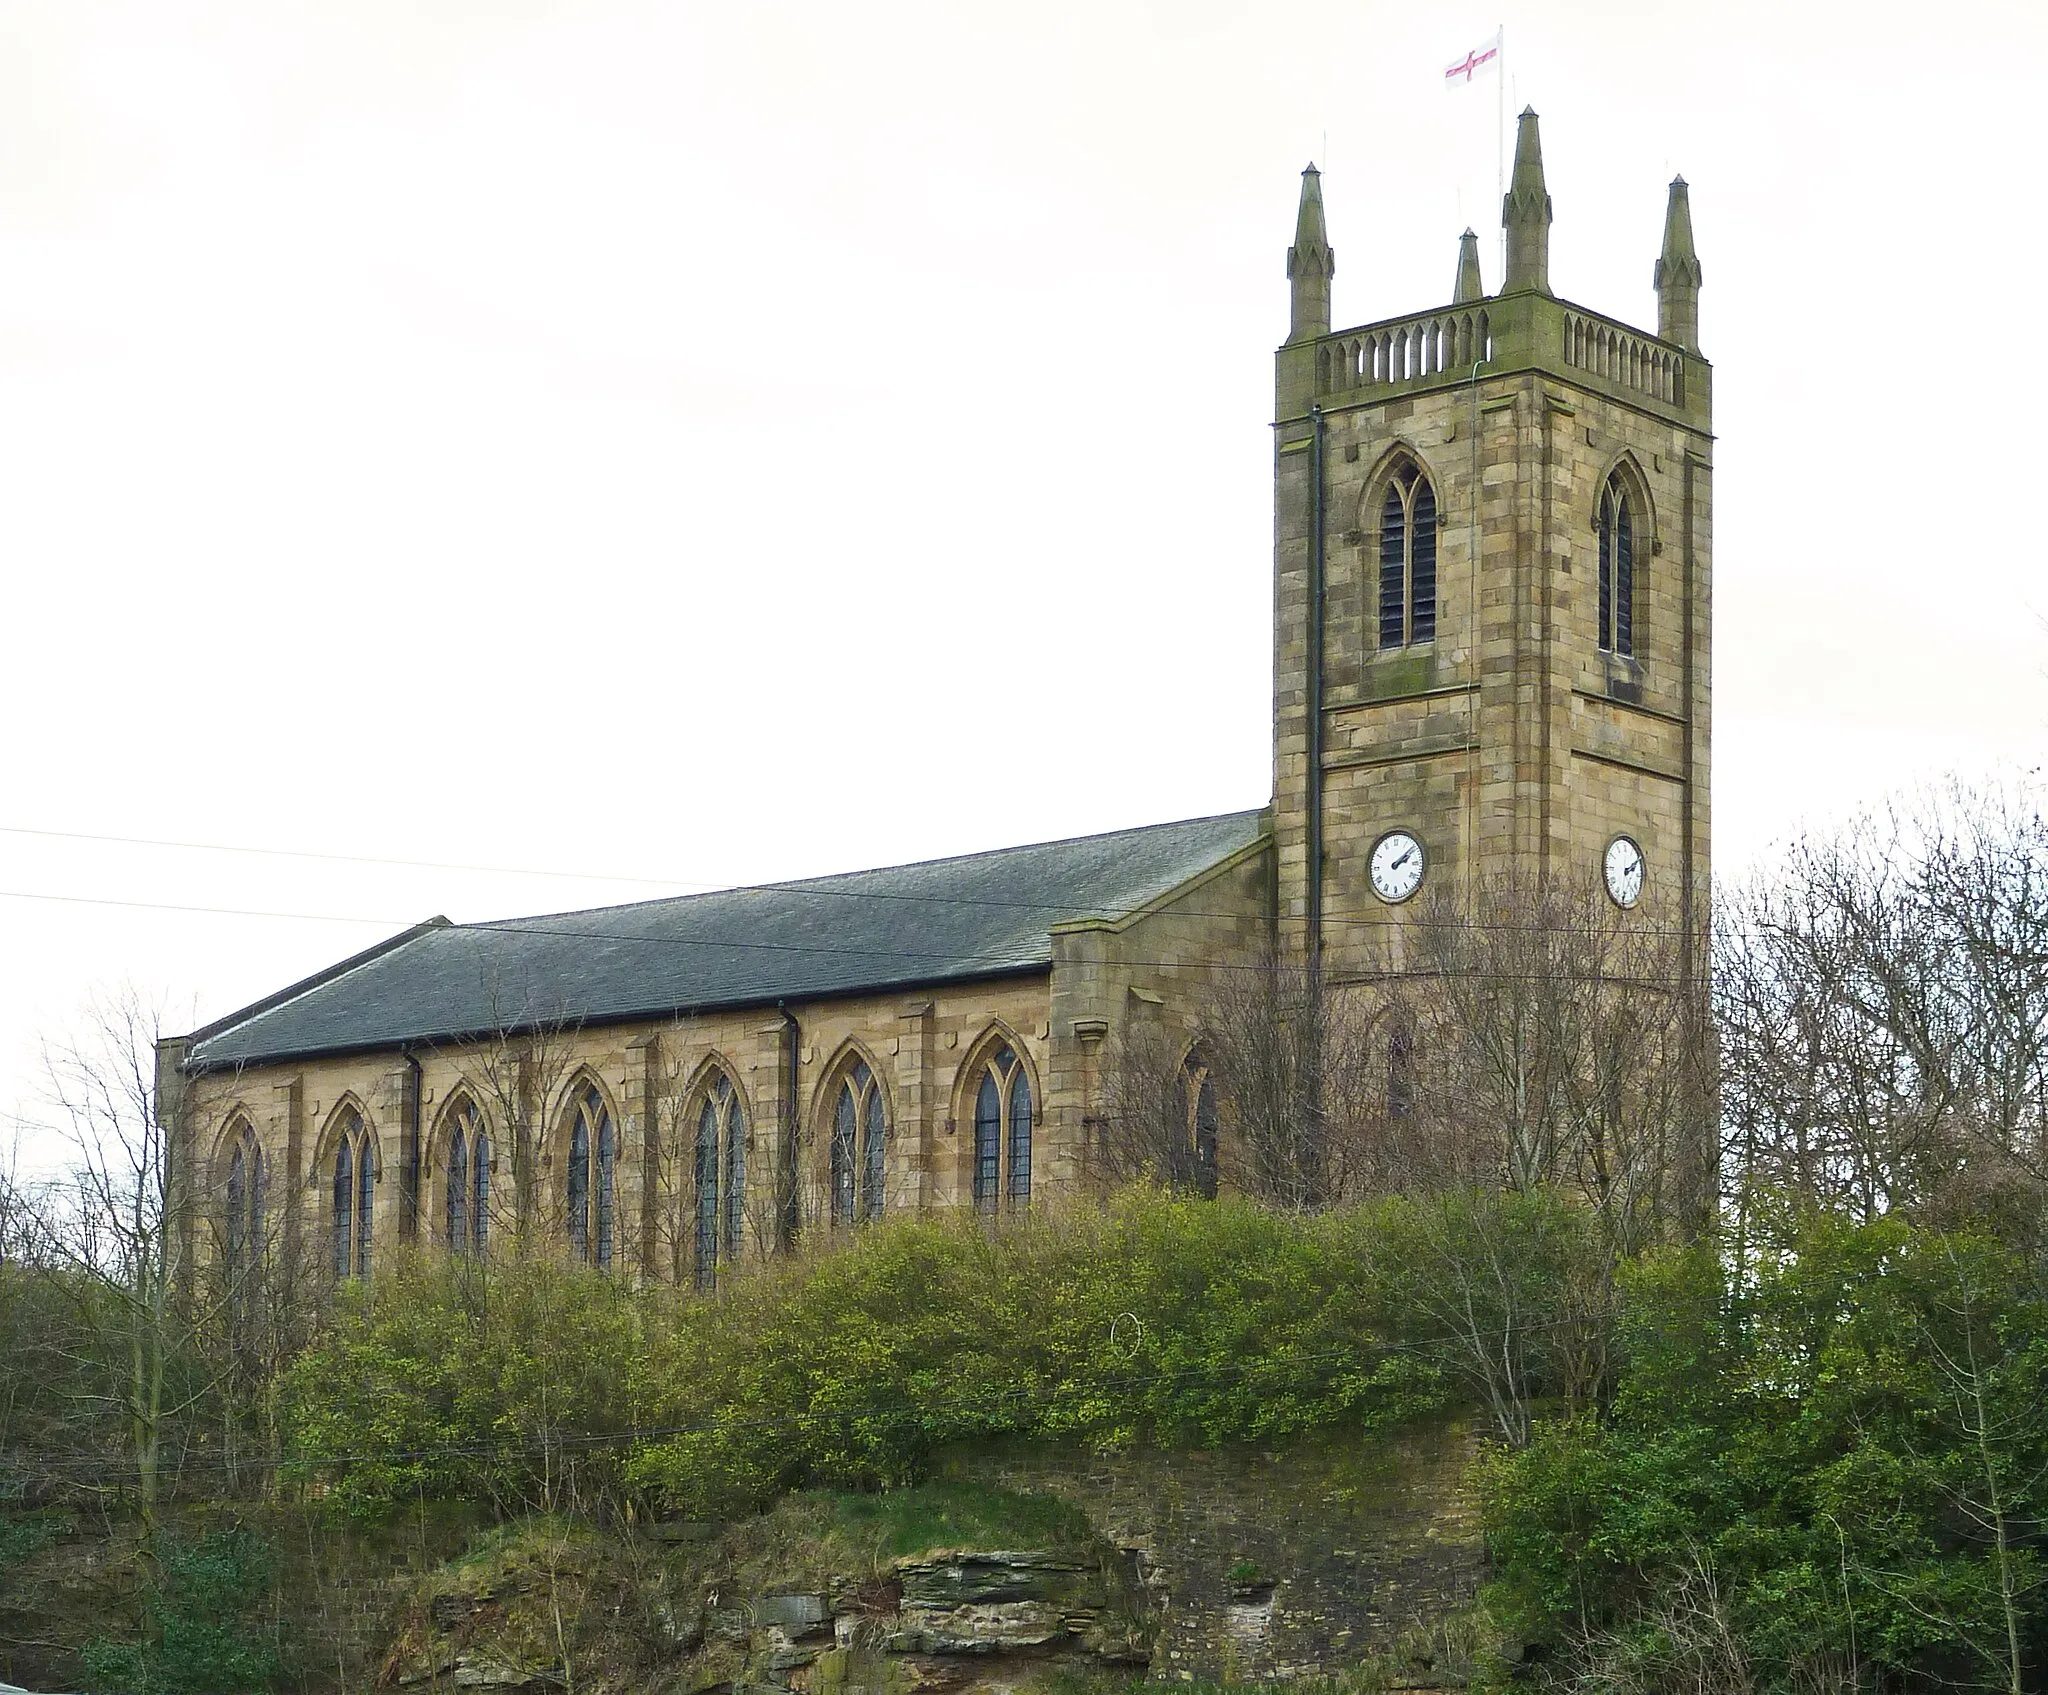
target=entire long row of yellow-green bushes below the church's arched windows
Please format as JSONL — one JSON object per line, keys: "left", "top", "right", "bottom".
{"left": 281, "top": 1193, "right": 1474, "bottom": 1517}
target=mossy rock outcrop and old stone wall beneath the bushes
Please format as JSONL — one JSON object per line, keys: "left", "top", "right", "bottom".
{"left": 383, "top": 1425, "right": 1483, "bottom": 1695}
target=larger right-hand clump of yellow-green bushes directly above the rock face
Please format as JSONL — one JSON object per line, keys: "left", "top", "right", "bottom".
{"left": 627, "top": 1191, "right": 1440, "bottom": 1515}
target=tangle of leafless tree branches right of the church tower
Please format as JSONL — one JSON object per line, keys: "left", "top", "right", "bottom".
{"left": 1714, "top": 786, "right": 2048, "bottom": 1220}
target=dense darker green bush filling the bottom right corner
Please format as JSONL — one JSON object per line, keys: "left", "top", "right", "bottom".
{"left": 1487, "top": 1218, "right": 2048, "bottom": 1689}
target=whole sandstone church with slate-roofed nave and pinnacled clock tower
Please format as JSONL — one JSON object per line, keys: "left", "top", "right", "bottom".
{"left": 158, "top": 111, "right": 1712, "bottom": 1286}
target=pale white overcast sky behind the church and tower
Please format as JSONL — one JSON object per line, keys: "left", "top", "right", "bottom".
{"left": 0, "top": 0, "right": 2048, "bottom": 1162}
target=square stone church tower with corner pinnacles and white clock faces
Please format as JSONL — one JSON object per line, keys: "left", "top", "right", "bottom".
{"left": 1272, "top": 111, "right": 1712, "bottom": 981}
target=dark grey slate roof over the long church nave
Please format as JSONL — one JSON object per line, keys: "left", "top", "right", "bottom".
{"left": 186, "top": 813, "right": 1264, "bottom": 1069}
